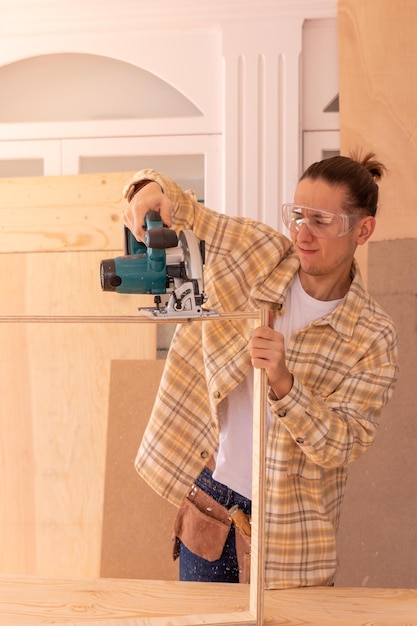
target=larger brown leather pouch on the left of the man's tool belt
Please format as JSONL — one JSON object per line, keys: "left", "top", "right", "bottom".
{"left": 173, "top": 485, "right": 232, "bottom": 561}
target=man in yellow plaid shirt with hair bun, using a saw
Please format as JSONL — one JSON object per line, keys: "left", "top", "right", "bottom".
{"left": 124, "top": 155, "right": 398, "bottom": 588}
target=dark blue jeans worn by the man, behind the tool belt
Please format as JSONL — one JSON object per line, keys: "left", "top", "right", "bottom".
{"left": 179, "top": 468, "right": 251, "bottom": 583}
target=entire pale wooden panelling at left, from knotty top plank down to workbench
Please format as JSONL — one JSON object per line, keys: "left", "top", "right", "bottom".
{"left": 0, "top": 175, "right": 156, "bottom": 577}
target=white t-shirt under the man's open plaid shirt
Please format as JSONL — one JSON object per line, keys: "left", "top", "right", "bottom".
{"left": 213, "top": 274, "right": 340, "bottom": 499}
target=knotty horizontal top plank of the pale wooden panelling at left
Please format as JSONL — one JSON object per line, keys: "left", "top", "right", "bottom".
{"left": 0, "top": 172, "right": 135, "bottom": 252}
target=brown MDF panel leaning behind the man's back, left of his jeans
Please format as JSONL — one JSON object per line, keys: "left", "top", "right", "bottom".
{"left": 100, "top": 359, "right": 178, "bottom": 580}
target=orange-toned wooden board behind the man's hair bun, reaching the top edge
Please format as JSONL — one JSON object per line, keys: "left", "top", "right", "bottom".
{"left": 338, "top": 0, "right": 417, "bottom": 241}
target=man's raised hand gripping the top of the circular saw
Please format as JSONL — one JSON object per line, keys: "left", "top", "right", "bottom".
{"left": 123, "top": 182, "right": 175, "bottom": 241}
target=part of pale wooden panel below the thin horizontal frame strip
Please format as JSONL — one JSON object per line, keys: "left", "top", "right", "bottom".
{"left": 0, "top": 324, "right": 155, "bottom": 576}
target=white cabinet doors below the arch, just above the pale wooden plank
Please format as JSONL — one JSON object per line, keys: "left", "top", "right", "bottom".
{"left": 0, "top": 135, "right": 222, "bottom": 207}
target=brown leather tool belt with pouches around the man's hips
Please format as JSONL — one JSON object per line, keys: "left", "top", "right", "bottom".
{"left": 173, "top": 485, "right": 250, "bottom": 583}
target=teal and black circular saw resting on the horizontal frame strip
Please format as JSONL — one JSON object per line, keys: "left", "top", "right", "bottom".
{"left": 100, "top": 211, "right": 215, "bottom": 317}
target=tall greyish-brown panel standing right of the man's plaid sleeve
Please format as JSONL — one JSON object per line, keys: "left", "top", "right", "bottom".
{"left": 337, "top": 239, "right": 417, "bottom": 588}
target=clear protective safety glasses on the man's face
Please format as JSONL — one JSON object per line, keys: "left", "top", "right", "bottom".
{"left": 282, "top": 203, "right": 366, "bottom": 239}
